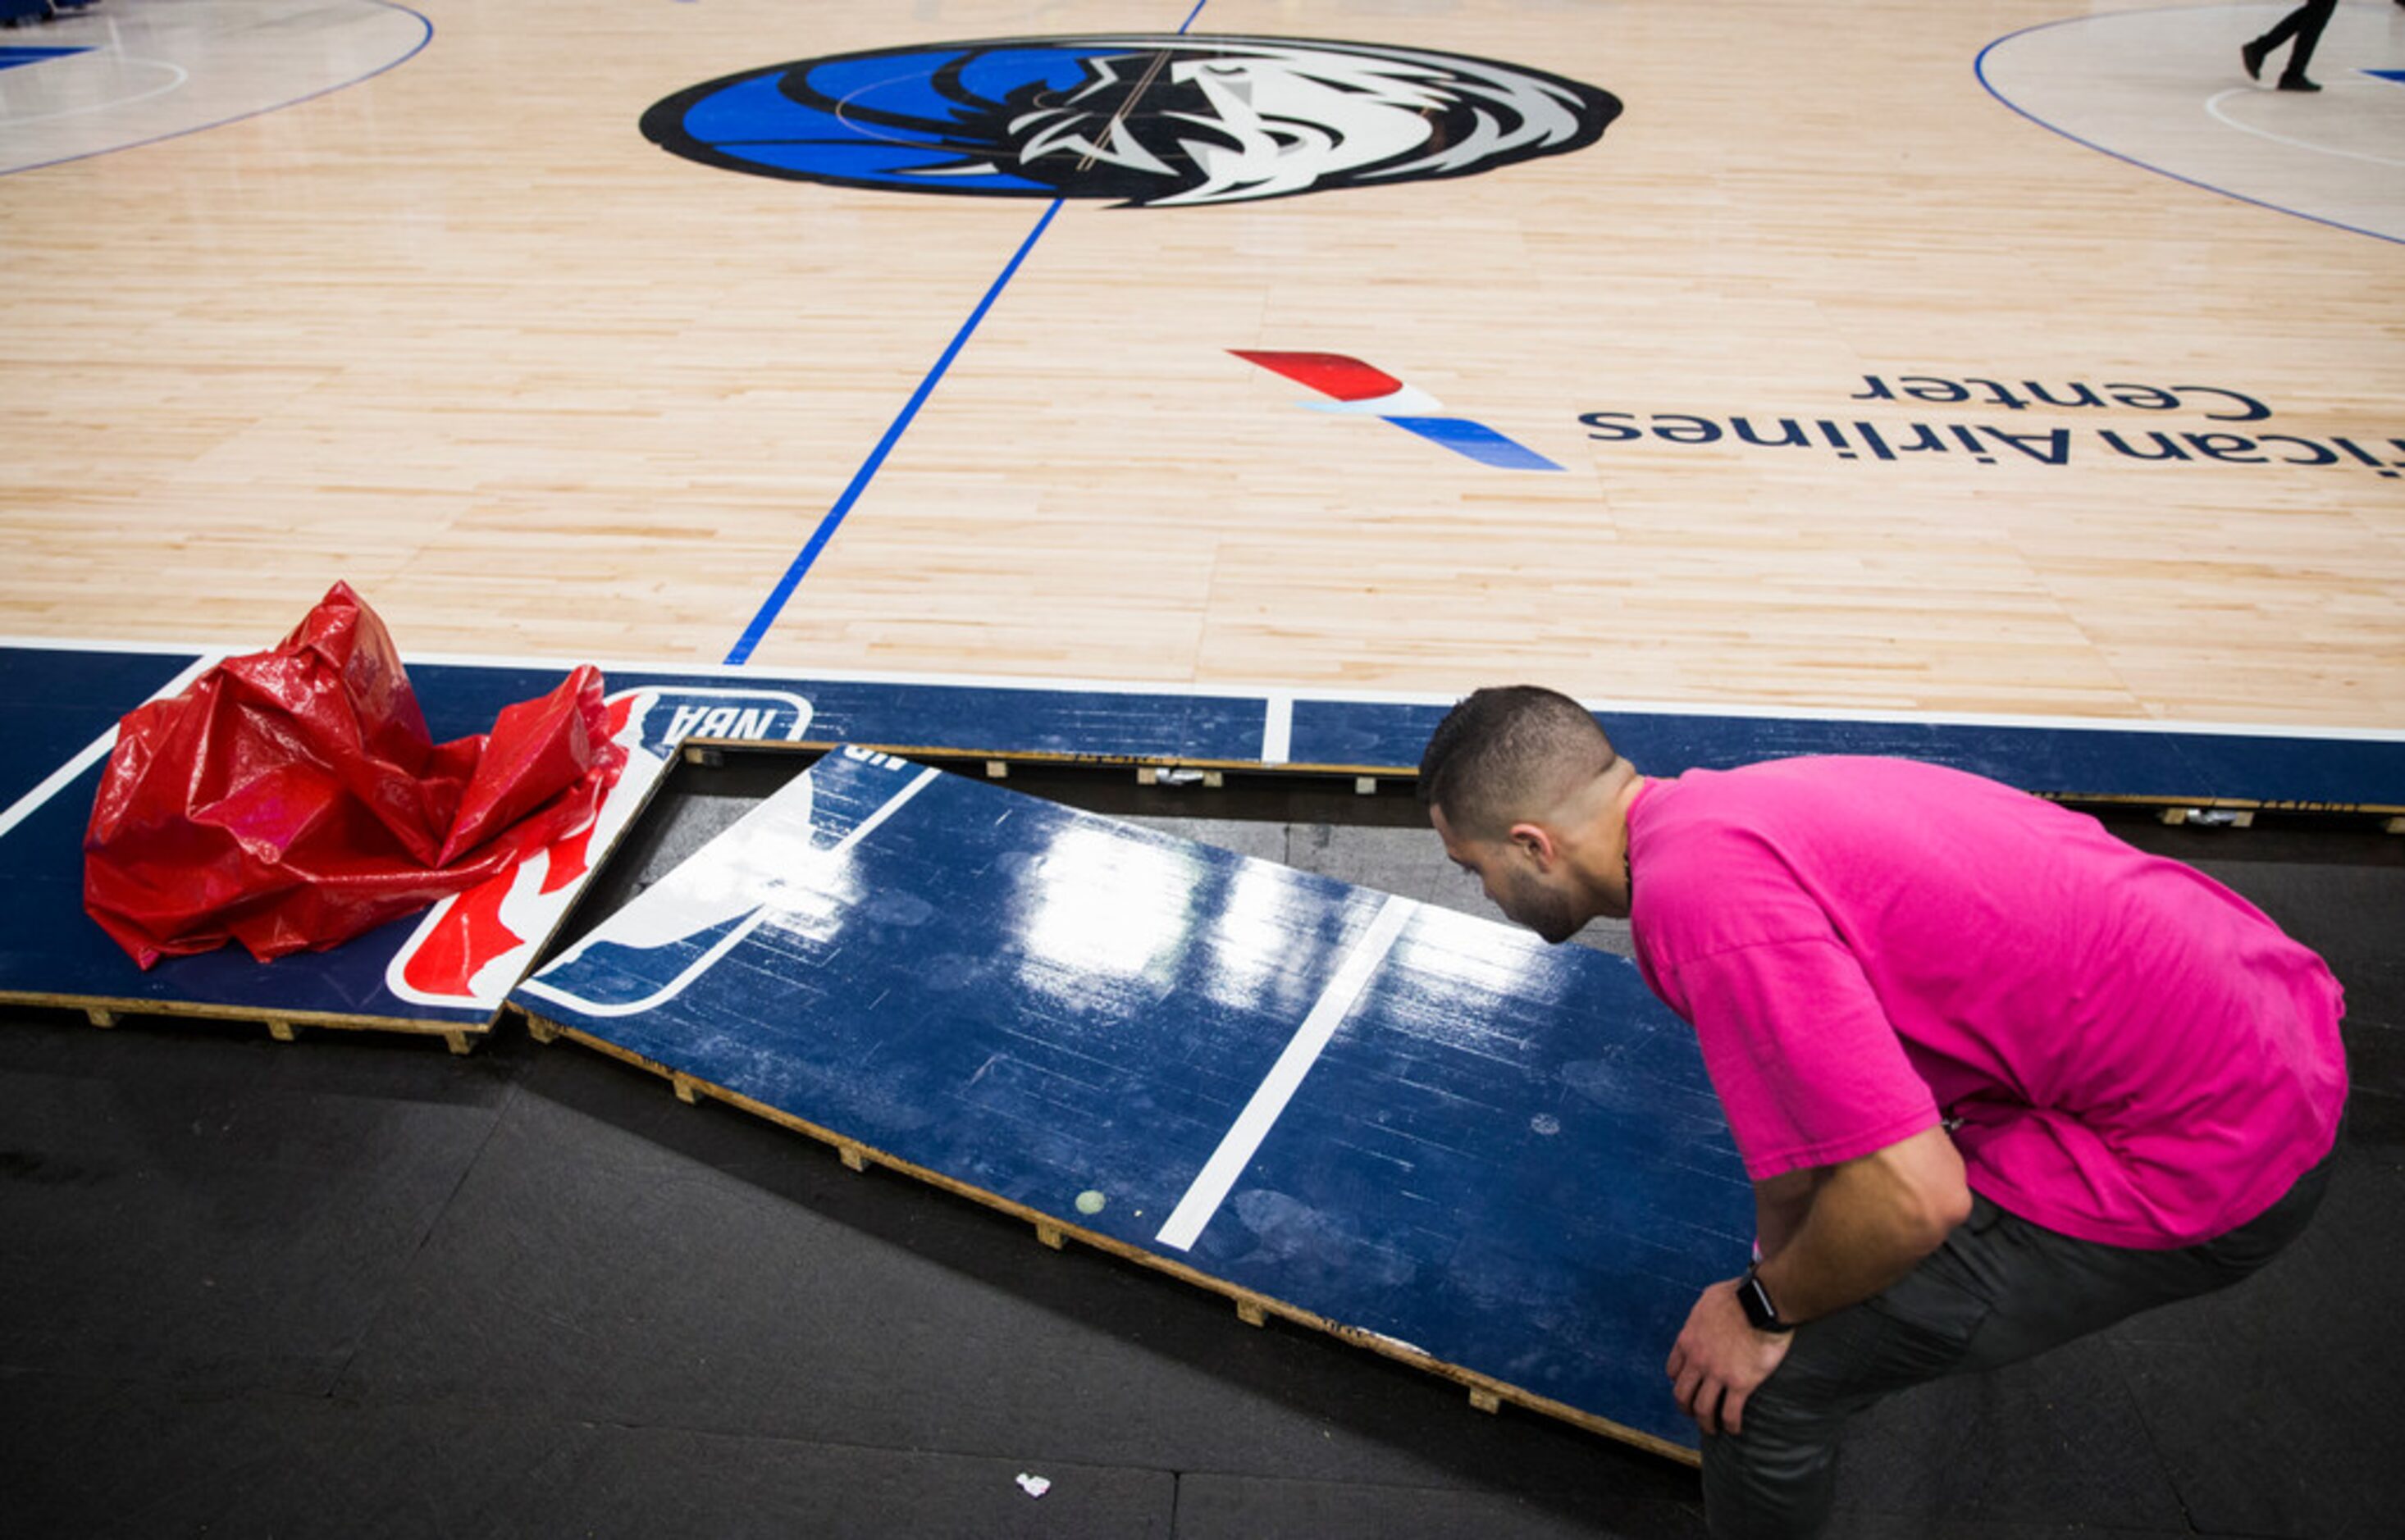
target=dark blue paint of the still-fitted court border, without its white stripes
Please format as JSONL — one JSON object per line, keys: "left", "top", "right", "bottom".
{"left": 0, "top": 649, "right": 2405, "bottom": 1023}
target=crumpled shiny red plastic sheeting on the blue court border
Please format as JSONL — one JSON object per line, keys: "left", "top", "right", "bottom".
{"left": 84, "top": 584, "right": 625, "bottom": 968}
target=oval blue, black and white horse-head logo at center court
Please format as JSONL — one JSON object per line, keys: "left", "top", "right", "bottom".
{"left": 642, "top": 34, "right": 1621, "bottom": 209}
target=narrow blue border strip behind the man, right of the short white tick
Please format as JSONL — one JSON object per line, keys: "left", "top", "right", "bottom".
{"left": 1289, "top": 699, "right": 2405, "bottom": 807}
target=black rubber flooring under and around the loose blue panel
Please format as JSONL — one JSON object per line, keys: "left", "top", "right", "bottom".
{"left": 0, "top": 792, "right": 2405, "bottom": 1540}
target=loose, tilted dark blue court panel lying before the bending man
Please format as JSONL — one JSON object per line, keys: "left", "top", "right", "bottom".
{"left": 514, "top": 754, "right": 1753, "bottom": 1447}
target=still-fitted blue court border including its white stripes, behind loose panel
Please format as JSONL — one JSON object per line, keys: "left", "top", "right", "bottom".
{"left": 0, "top": 636, "right": 2405, "bottom": 1033}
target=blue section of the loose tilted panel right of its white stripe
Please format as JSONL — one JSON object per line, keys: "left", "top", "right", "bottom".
{"left": 1231, "top": 910, "right": 1753, "bottom": 1444}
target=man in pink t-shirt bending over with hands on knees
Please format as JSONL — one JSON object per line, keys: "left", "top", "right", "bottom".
{"left": 1419, "top": 687, "right": 2348, "bottom": 1538}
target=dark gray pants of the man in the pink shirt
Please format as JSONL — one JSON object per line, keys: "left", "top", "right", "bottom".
{"left": 1703, "top": 1158, "right": 2330, "bottom": 1540}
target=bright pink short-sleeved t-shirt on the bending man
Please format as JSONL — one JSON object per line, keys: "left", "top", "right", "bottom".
{"left": 1628, "top": 759, "right": 2348, "bottom": 1247}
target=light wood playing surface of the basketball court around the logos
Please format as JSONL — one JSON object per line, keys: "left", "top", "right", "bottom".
{"left": 0, "top": 0, "right": 2405, "bottom": 728}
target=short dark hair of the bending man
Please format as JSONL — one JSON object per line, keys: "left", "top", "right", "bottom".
{"left": 1419, "top": 685, "right": 1618, "bottom": 838}
